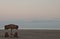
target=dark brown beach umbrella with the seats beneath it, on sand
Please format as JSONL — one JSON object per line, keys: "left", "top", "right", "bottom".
{"left": 5, "top": 24, "right": 18, "bottom": 37}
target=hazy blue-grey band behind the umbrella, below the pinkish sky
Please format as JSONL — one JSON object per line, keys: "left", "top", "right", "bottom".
{"left": 0, "top": 20, "right": 60, "bottom": 29}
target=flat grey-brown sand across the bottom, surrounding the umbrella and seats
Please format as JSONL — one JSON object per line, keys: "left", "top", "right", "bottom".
{"left": 0, "top": 30, "right": 60, "bottom": 39}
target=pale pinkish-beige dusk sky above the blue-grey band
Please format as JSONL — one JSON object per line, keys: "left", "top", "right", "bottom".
{"left": 0, "top": 0, "right": 60, "bottom": 29}
